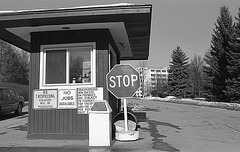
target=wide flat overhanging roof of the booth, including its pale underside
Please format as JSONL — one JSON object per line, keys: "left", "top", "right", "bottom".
{"left": 0, "top": 3, "right": 152, "bottom": 60}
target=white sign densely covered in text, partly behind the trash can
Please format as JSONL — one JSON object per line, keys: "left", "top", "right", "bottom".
{"left": 77, "top": 88, "right": 103, "bottom": 114}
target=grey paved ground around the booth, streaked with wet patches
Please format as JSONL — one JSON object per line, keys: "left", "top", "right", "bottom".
{"left": 0, "top": 99, "right": 240, "bottom": 152}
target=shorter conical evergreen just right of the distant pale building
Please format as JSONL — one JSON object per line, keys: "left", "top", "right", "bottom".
{"left": 168, "top": 46, "right": 190, "bottom": 98}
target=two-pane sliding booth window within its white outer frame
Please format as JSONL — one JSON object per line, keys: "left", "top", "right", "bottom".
{"left": 40, "top": 45, "right": 94, "bottom": 86}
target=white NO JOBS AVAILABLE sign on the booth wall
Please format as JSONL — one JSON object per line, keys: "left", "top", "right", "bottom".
{"left": 58, "top": 89, "right": 77, "bottom": 109}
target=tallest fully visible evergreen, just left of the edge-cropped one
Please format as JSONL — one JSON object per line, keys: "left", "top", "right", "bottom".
{"left": 204, "top": 6, "right": 234, "bottom": 102}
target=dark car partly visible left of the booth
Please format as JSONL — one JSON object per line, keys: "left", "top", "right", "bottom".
{"left": 0, "top": 87, "right": 25, "bottom": 115}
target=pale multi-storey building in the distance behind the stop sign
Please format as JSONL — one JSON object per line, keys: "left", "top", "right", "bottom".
{"left": 135, "top": 66, "right": 169, "bottom": 97}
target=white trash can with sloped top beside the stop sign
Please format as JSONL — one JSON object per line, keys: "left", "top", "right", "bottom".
{"left": 89, "top": 100, "right": 112, "bottom": 146}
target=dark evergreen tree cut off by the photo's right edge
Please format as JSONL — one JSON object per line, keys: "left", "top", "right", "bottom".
{"left": 225, "top": 8, "right": 240, "bottom": 103}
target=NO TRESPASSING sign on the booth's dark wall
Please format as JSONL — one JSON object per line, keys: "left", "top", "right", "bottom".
{"left": 33, "top": 89, "right": 57, "bottom": 109}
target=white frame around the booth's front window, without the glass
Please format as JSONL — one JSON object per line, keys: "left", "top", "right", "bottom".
{"left": 39, "top": 42, "right": 96, "bottom": 89}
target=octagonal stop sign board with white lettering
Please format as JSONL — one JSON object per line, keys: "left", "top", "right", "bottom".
{"left": 106, "top": 64, "right": 140, "bottom": 99}
